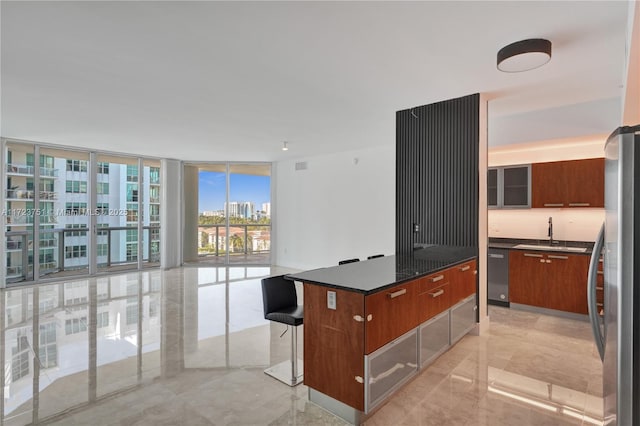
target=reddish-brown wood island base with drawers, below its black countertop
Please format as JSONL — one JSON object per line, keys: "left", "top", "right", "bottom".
{"left": 303, "top": 260, "right": 476, "bottom": 413}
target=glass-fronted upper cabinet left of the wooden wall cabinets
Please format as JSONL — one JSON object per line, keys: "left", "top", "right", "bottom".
{"left": 487, "top": 164, "right": 531, "bottom": 208}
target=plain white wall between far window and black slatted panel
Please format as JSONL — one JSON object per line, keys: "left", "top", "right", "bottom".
{"left": 273, "top": 144, "right": 396, "bottom": 269}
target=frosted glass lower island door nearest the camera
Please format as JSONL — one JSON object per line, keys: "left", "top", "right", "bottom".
{"left": 365, "top": 328, "right": 418, "bottom": 413}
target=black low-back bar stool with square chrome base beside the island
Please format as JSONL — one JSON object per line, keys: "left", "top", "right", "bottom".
{"left": 262, "top": 275, "right": 304, "bottom": 386}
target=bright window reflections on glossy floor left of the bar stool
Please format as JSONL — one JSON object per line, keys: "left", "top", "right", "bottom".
{"left": 0, "top": 267, "right": 294, "bottom": 425}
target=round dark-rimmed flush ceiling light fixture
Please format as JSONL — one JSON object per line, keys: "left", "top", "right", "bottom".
{"left": 498, "top": 38, "right": 551, "bottom": 72}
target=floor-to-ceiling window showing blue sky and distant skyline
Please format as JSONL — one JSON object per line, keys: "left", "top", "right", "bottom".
{"left": 184, "top": 163, "right": 271, "bottom": 265}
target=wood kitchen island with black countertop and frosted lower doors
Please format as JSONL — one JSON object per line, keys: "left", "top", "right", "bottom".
{"left": 288, "top": 246, "right": 477, "bottom": 424}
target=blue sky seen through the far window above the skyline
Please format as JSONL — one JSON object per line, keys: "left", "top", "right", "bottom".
{"left": 198, "top": 171, "right": 271, "bottom": 212}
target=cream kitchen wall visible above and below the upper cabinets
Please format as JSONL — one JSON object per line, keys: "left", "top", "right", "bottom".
{"left": 488, "top": 135, "right": 607, "bottom": 241}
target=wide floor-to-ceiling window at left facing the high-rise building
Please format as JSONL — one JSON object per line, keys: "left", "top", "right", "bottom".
{"left": 4, "top": 141, "right": 161, "bottom": 283}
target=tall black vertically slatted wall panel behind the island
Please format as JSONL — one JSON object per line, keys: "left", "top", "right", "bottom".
{"left": 396, "top": 94, "right": 480, "bottom": 253}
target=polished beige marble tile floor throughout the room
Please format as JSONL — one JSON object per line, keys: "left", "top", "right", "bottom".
{"left": 0, "top": 268, "right": 602, "bottom": 426}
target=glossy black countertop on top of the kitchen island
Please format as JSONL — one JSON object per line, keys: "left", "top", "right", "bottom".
{"left": 287, "top": 246, "right": 478, "bottom": 295}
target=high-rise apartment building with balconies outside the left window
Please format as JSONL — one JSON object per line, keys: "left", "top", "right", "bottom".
{"left": 5, "top": 145, "right": 160, "bottom": 281}
